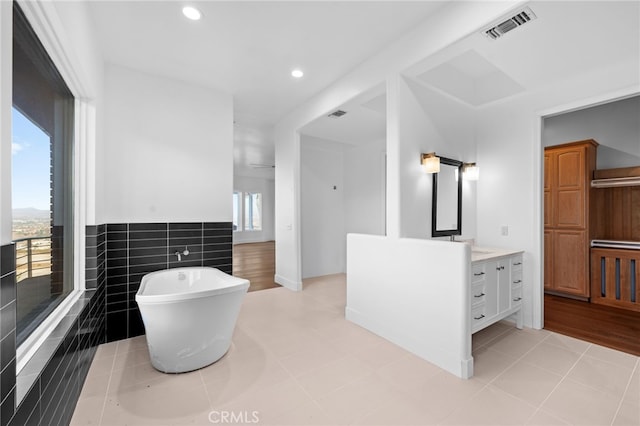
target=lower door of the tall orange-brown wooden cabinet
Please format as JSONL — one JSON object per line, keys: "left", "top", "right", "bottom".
{"left": 545, "top": 230, "right": 589, "bottom": 297}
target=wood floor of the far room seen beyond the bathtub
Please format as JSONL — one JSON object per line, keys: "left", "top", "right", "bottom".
{"left": 233, "top": 241, "right": 280, "bottom": 291}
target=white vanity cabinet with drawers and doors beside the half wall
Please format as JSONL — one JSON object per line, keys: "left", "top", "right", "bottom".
{"left": 470, "top": 251, "right": 523, "bottom": 333}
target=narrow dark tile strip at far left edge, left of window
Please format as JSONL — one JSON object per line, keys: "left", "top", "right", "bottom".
{"left": 0, "top": 244, "right": 16, "bottom": 425}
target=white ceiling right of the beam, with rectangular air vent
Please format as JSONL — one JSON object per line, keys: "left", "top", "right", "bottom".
{"left": 302, "top": 1, "right": 640, "bottom": 154}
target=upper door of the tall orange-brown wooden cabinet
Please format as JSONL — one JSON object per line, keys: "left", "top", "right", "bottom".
{"left": 551, "top": 148, "right": 585, "bottom": 228}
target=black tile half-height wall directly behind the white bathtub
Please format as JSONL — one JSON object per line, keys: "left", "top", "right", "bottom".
{"left": 105, "top": 222, "right": 233, "bottom": 341}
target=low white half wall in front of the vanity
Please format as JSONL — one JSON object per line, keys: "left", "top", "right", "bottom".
{"left": 345, "top": 234, "right": 473, "bottom": 378}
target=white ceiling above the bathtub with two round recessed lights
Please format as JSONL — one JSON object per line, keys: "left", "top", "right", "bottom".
{"left": 89, "top": 0, "right": 444, "bottom": 176}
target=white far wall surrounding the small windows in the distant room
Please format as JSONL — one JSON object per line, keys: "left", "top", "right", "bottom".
{"left": 233, "top": 175, "right": 275, "bottom": 244}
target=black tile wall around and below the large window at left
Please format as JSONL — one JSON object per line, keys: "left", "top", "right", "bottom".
{"left": 0, "top": 230, "right": 106, "bottom": 426}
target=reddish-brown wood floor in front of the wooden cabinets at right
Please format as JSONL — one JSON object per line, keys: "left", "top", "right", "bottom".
{"left": 544, "top": 294, "right": 640, "bottom": 356}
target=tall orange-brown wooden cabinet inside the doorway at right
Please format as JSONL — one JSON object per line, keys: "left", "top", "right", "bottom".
{"left": 544, "top": 140, "right": 598, "bottom": 298}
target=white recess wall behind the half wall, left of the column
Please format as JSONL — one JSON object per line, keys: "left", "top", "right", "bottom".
{"left": 300, "top": 135, "right": 385, "bottom": 278}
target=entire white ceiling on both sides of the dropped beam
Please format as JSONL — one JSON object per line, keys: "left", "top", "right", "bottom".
{"left": 89, "top": 0, "right": 640, "bottom": 177}
